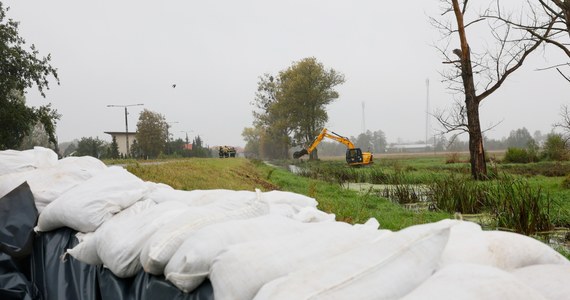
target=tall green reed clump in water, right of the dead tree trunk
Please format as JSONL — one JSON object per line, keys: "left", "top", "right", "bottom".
{"left": 488, "top": 176, "right": 553, "bottom": 235}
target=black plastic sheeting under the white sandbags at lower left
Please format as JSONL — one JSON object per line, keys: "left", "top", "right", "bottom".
{"left": 0, "top": 183, "right": 214, "bottom": 300}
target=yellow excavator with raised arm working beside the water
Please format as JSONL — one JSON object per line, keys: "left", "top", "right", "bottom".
{"left": 293, "top": 128, "right": 373, "bottom": 166}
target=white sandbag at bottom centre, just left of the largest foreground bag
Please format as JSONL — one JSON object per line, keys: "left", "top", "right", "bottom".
{"left": 210, "top": 222, "right": 386, "bottom": 300}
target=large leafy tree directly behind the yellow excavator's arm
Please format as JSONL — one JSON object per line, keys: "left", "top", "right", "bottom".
{"left": 247, "top": 57, "right": 344, "bottom": 159}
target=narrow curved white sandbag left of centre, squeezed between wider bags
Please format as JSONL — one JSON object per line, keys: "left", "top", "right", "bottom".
{"left": 140, "top": 194, "right": 269, "bottom": 275}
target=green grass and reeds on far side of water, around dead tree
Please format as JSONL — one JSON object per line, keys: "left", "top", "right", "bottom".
{"left": 288, "top": 155, "right": 570, "bottom": 234}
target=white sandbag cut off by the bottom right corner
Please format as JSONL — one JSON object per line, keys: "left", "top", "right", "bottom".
{"left": 511, "top": 265, "right": 570, "bottom": 300}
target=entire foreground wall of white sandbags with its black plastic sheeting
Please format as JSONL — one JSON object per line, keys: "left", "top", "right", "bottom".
{"left": 0, "top": 148, "right": 570, "bottom": 299}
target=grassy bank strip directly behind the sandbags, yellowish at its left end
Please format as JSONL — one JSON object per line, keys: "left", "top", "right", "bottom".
{"left": 126, "top": 158, "right": 451, "bottom": 230}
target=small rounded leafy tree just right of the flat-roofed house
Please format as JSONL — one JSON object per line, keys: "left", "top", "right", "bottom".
{"left": 136, "top": 109, "right": 168, "bottom": 158}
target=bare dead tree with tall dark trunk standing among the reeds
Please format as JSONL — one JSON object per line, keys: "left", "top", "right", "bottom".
{"left": 432, "top": 0, "right": 554, "bottom": 180}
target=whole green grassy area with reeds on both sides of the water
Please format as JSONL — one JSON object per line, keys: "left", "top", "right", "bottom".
{"left": 121, "top": 155, "right": 570, "bottom": 255}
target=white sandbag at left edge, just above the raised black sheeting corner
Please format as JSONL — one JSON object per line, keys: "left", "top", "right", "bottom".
{"left": 0, "top": 156, "right": 107, "bottom": 213}
